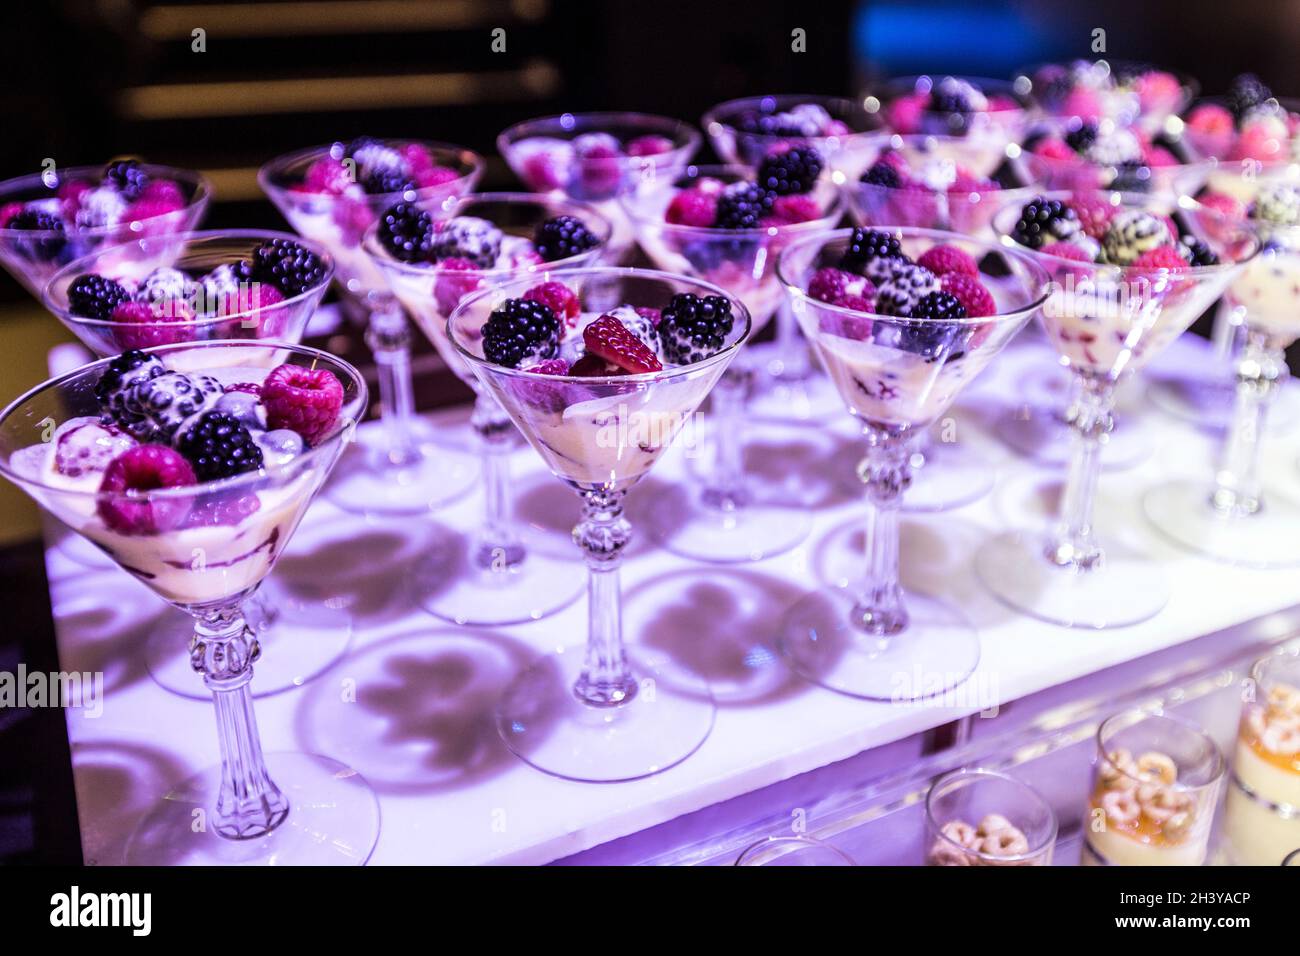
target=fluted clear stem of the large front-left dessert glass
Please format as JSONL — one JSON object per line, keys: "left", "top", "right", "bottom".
{"left": 190, "top": 604, "right": 289, "bottom": 840}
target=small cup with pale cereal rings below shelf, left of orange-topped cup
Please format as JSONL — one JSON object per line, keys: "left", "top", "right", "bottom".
{"left": 926, "top": 769, "right": 1057, "bottom": 866}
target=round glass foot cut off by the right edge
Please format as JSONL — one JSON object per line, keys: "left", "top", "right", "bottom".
{"left": 1143, "top": 481, "right": 1300, "bottom": 568}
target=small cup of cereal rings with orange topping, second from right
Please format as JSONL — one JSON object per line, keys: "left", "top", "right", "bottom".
{"left": 1082, "top": 710, "right": 1225, "bottom": 866}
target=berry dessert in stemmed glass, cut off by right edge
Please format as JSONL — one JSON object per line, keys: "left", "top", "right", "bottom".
{"left": 1143, "top": 171, "right": 1300, "bottom": 567}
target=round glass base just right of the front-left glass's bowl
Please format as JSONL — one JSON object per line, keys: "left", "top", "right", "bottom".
{"left": 325, "top": 427, "right": 478, "bottom": 515}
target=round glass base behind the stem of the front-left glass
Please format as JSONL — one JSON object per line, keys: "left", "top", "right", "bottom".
{"left": 144, "top": 575, "right": 352, "bottom": 700}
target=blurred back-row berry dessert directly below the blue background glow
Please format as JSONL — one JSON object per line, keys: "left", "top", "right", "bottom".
{"left": 870, "top": 74, "right": 1028, "bottom": 147}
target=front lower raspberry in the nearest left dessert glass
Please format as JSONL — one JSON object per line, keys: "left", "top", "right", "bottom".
{"left": 95, "top": 445, "right": 198, "bottom": 535}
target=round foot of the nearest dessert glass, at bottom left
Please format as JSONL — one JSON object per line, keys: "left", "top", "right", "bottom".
{"left": 125, "top": 753, "right": 380, "bottom": 866}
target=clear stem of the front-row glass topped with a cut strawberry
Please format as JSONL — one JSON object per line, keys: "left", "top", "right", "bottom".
{"left": 573, "top": 490, "right": 637, "bottom": 708}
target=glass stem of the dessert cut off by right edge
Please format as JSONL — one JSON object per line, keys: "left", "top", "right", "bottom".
{"left": 1212, "top": 332, "right": 1287, "bottom": 518}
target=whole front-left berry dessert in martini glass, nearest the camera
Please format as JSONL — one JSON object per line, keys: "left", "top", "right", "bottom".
{"left": 0, "top": 341, "right": 380, "bottom": 865}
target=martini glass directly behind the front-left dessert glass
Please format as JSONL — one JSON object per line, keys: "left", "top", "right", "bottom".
{"left": 44, "top": 229, "right": 352, "bottom": 698}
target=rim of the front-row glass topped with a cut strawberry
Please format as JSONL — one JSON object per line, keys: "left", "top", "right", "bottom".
{"left": 447, "top": 265, "right": 754, "bottom": 385}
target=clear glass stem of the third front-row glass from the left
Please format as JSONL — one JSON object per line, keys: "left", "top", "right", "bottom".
{"left": 853, "top": 425, "right": 911, "bottom": 637}
